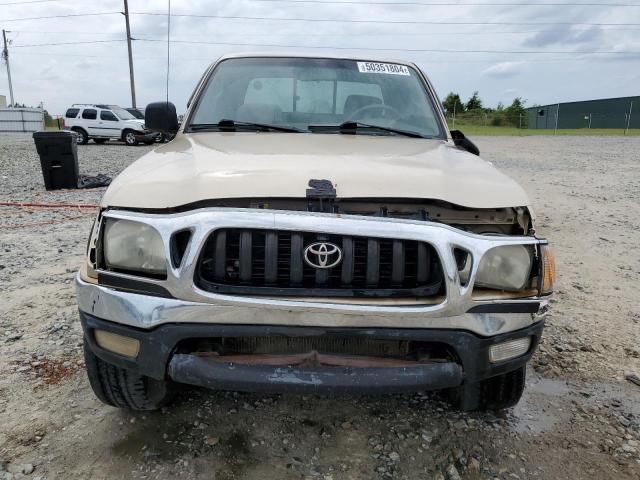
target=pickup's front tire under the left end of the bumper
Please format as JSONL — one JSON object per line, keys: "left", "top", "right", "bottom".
{"left": 84, "top": 340, "right": 173, "bottom": 411}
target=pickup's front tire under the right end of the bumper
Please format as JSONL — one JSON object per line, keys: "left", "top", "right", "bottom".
{"left": 449, "top": 367, "right": 526, "bottom": 412}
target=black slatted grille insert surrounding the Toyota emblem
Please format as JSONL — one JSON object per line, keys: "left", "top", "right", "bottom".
{"left": 195, "top": 229, "right": 446, "bottom": 298}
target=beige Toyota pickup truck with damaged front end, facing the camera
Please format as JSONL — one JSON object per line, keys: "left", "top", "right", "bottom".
{"left": 76, "top": 54, "right": 555, "bottom": 410}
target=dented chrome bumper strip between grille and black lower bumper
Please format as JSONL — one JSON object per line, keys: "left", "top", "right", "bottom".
{"left": 76, "top": 276, "right": 537, "bottom": 336}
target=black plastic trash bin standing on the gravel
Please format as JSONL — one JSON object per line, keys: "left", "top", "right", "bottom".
{"left": 33, "top": 130, "right": 78, "bottom": 190}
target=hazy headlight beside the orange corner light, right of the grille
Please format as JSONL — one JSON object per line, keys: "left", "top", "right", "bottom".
{"left": 475, "top": 245, "right": 533, "bottom": 291}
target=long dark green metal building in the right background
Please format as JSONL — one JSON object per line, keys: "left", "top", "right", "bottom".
{"left": 527, "top": 96, "right": 640, "bottom": 129}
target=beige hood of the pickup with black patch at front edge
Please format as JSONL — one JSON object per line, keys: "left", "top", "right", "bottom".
{"left": 102, "top": 132, "right": 529, "bottom": 209}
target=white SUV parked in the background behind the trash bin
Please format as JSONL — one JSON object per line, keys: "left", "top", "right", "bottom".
{"left": 64, "top": 104, "right": 156, "bottom": 145}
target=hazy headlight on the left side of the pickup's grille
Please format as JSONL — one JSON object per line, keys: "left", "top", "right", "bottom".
{"left": 104, "top": 218, "right": 167, "bottom": 275}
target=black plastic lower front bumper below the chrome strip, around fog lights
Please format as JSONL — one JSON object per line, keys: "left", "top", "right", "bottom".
{"left": 80, "top": 311, "right": 544, "bottom": 393}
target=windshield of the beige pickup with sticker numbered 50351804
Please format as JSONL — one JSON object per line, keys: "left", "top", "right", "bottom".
{"left": 187, "top": 58, "right": 444, "bottom": 137}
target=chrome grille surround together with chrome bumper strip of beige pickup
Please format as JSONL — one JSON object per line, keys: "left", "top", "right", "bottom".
{"left": 76, "top": 208, "right": 546, "bottom": 336}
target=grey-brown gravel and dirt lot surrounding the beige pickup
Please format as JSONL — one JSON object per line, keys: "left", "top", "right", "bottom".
{"left": 0, "top": 135, "right": 640, "bottom": 480}
